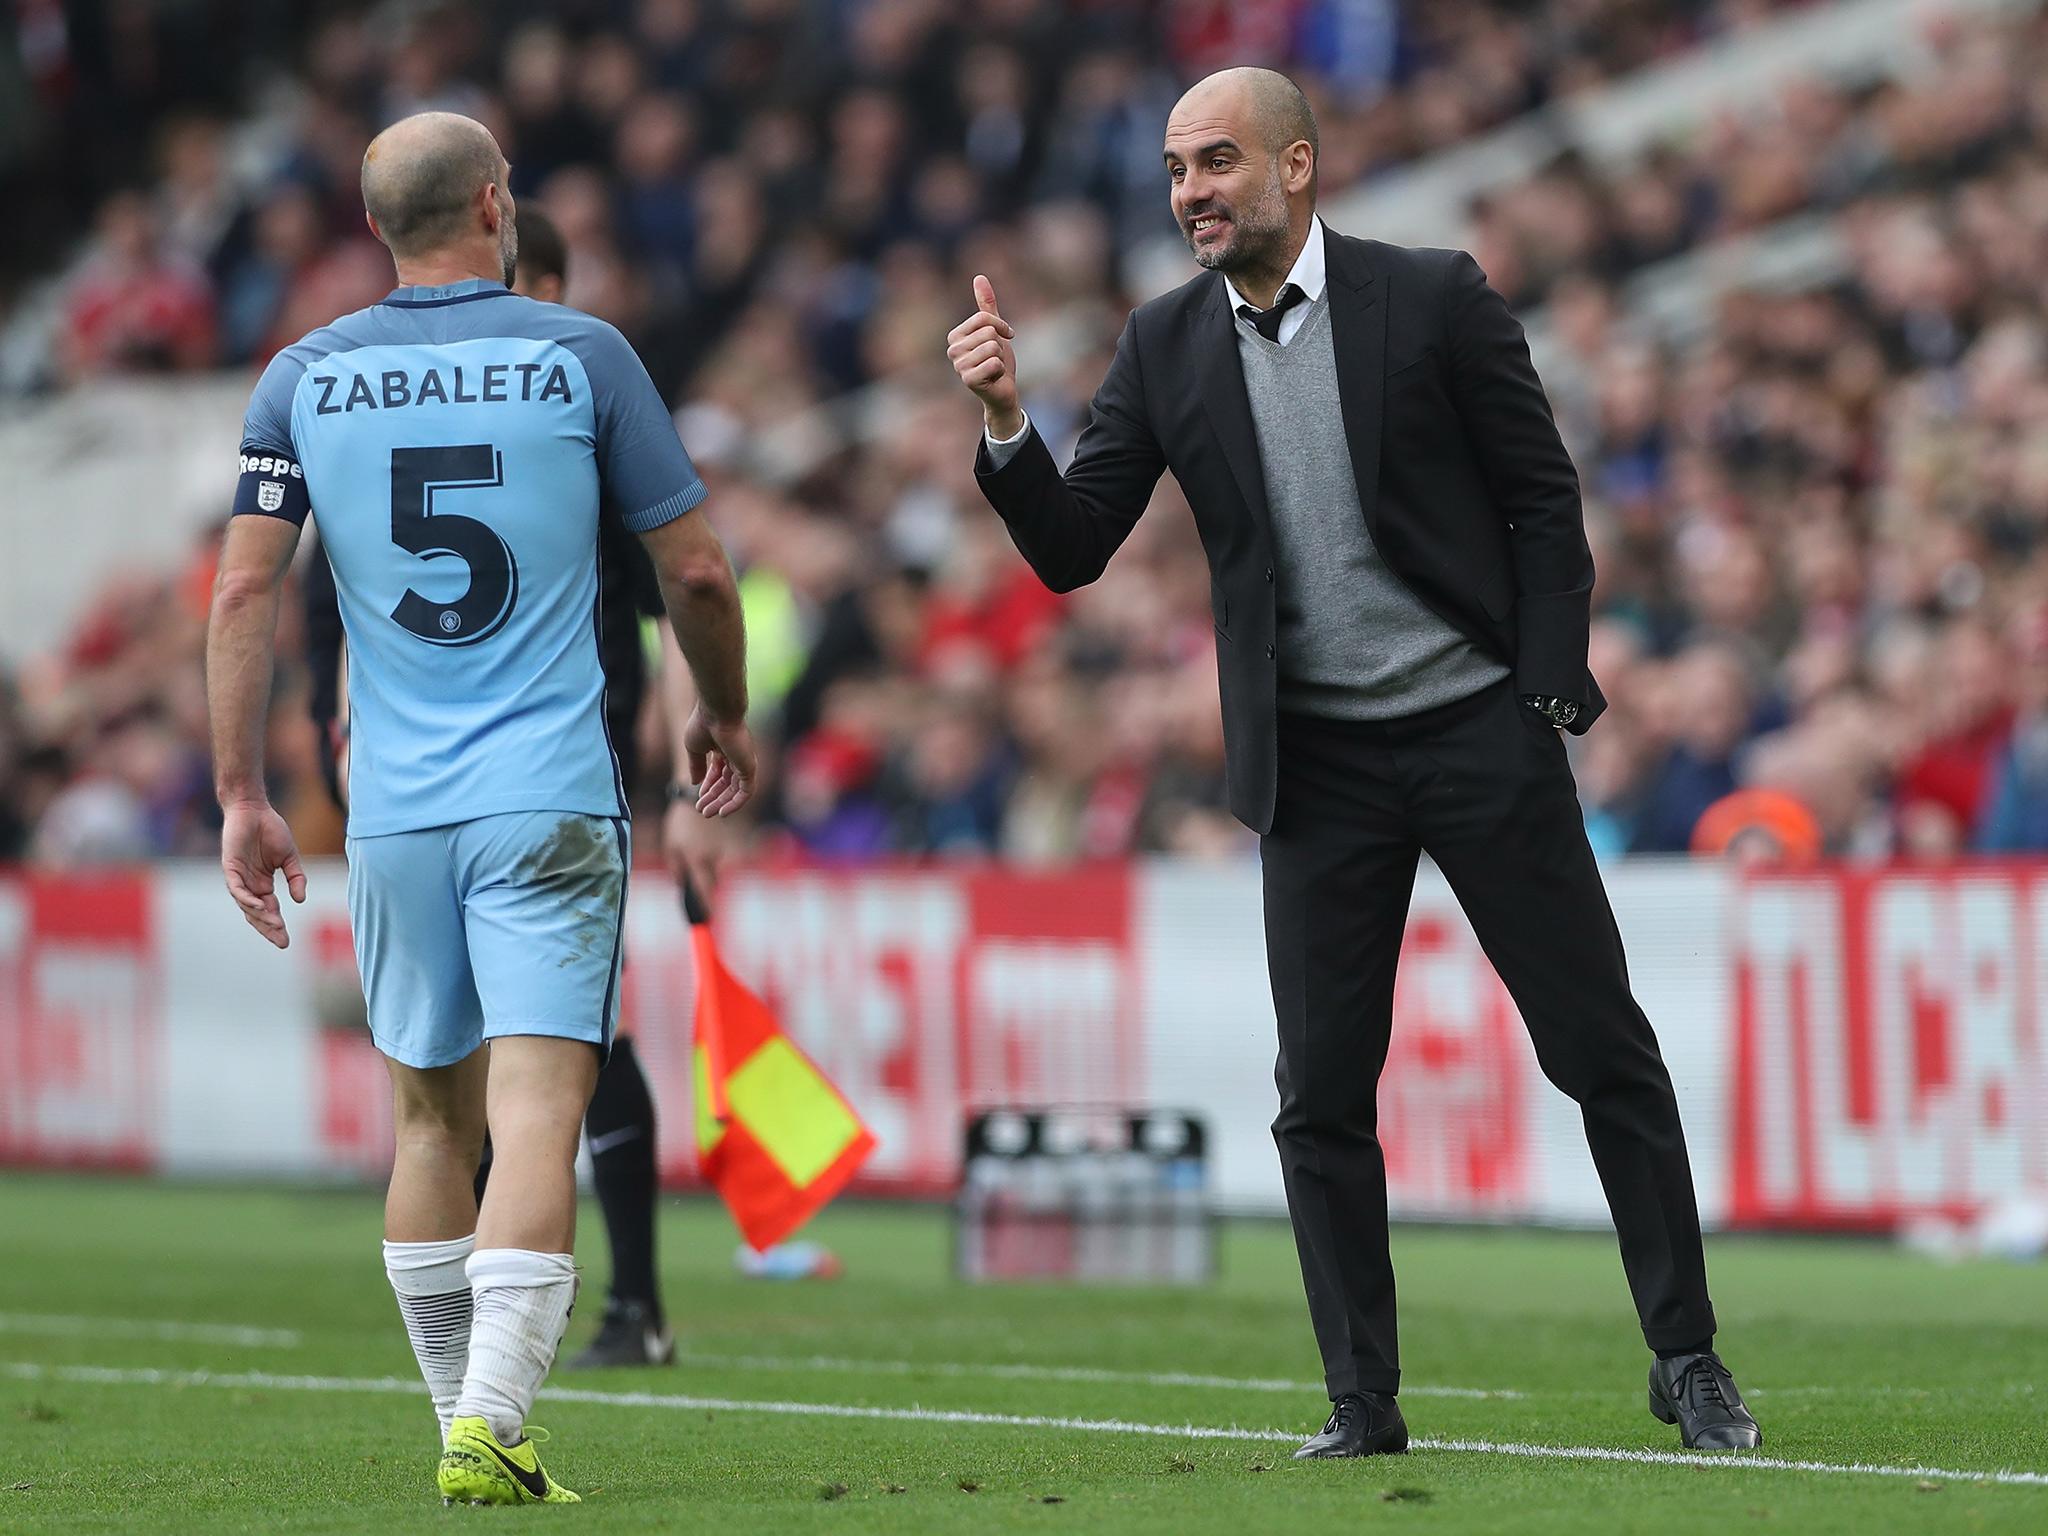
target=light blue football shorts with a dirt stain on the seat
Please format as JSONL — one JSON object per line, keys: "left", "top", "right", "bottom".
{"left": 348, "top": 811, "right": 633, "bottom": 1067}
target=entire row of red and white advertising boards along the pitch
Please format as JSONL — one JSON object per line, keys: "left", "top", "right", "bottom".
{"left": 0, "top": 862, "right": 2048, "bottom": 1231}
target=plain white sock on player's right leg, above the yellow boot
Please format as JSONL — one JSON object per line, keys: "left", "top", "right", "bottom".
{"left": 455, "top": 1247, "right": 575, "bottom": 1446}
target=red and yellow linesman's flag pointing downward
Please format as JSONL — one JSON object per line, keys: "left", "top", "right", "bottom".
{"left": 682, "top": 889, "right": 874, "bottom": 1251}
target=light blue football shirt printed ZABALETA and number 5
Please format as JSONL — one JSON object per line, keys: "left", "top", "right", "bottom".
{"left": 236, "top": 279, "right": 705, "bottom": 838}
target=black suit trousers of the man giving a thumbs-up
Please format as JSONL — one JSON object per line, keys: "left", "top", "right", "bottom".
{"left": 1260, "top": 682, "right": 1714, "bottom": 1399}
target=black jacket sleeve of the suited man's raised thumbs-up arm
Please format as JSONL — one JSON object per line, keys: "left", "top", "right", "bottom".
{"left": 975, "top": 315, "right": 1165, "bottom": 592}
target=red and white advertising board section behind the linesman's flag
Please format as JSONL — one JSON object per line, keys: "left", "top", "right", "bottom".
{"left": 625, "top": 866, "right": 1143, "bottom": 1194}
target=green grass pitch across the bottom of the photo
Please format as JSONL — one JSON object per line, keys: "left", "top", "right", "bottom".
{"left": 0, "top": 1174, "right": 2048, "bottom": 1536}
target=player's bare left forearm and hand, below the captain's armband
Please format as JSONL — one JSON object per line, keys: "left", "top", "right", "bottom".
{"left": 207, "top": 516, "right": 305, "bottom": 948}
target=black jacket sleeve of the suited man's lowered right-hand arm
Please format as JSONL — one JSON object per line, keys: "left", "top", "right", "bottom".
{"left": 1444, "top": 252, "right": 1593, "bottom": 705}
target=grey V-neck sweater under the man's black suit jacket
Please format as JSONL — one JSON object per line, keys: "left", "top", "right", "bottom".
{"left": 1237, "top": 299, "right": 1507, "bottom": 721}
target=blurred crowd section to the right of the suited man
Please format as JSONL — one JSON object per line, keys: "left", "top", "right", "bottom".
{"left": 1531, "top": 3, "right": 2048, "bottom": 856}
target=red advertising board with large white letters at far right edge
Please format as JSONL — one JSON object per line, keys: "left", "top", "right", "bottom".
{"left": 1726, "top": 864, "right": 2048, "bottom": 1229}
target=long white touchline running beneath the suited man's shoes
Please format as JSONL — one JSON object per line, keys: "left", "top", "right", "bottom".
{"left": 0, "top": 1360, "right": 2048, "bottom": 1487}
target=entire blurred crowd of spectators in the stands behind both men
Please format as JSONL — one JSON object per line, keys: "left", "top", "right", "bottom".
{"left": 12, "top": 0, "right": 2048, "bottom": 862}
